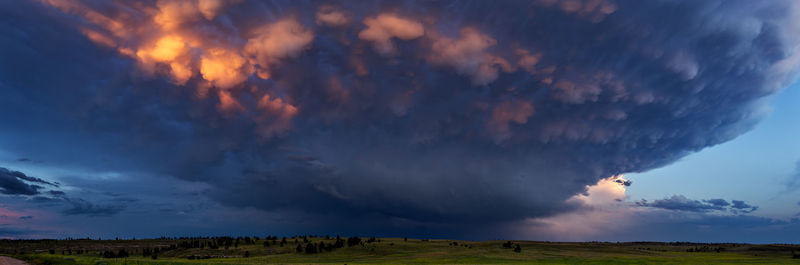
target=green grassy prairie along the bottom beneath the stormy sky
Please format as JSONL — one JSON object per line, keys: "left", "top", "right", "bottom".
{"left": 0, "top": 237, "right": 800, "bottom": 265}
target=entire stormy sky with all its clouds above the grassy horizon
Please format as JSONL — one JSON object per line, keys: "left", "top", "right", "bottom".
{"left": 0, "top": 0, "right": 800, "bottom": 243}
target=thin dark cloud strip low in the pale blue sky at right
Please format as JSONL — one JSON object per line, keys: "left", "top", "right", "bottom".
{"left": 636, "top": 195, "right": 758, "bottom": 213}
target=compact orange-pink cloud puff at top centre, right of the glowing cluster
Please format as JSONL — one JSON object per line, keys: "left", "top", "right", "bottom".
{"left": 358, "top": 13, "right": 425, "bottom": 56}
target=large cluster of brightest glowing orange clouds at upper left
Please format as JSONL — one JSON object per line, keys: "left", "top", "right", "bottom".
{"left": 42, "top": 0, "right": 310, "bottom": 137}
